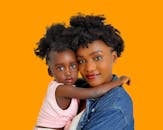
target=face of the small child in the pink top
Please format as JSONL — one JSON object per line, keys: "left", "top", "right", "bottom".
{"left": 49, "top": 50, "right": 78, "bottom": 85}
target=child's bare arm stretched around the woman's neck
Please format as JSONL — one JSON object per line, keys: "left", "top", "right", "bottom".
{"left": 56, "top": 76, "right": 130, "bottom": 99}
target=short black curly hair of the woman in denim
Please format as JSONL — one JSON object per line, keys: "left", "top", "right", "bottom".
{"left": 66, "top": 14, "right": 124, "bottom": 57}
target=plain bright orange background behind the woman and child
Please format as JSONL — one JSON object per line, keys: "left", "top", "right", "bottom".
{"left": 0, "top": 0, "right": 163, "bottom": 130}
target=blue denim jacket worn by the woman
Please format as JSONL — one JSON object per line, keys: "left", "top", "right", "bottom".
{"left": 77, "top": 76, "right": 134, "bottom": 130}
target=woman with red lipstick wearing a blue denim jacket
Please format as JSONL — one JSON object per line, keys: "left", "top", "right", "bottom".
{"left": 66, "top": 15, "right": 134, "bottom": 130}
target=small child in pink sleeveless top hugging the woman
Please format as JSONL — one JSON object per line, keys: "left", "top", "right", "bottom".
{"left": 35, "top": 24, "right": 129, "bottom": 130}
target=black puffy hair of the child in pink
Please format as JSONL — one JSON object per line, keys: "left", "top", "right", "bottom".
{"left": 34, "top": 24, "right": 70, "bottom": 76}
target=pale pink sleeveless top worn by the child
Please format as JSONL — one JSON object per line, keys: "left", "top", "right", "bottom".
{"left": 36, "top": 81, "right": 78, "bottom": 128}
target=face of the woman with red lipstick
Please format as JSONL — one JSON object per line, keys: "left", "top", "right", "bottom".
{"left": 77, "top": 40, "right": 117, "bottom": 87}
